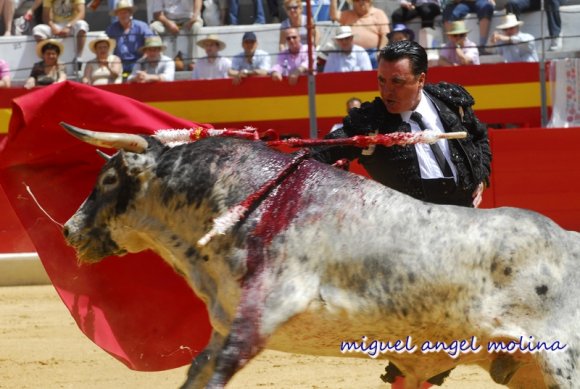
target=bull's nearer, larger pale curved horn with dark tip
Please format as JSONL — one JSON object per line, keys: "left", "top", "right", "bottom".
{"left": 60, "top": 122, "right": 147, "bottom": 153}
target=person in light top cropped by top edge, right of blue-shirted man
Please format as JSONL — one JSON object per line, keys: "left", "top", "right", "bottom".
{"left": 151, "top": 0, "right": 203, "bottom": 64}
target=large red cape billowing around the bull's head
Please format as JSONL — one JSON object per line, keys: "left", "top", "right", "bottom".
{"left": 0, "top": 82, "right": 211, "bottom": 371}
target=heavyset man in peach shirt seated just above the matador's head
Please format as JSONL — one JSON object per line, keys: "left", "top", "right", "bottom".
{"left": 330, "top": 0, "right": 390, "bottom": 69}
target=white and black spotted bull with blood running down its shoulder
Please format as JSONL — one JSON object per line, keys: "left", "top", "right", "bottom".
{"left": 64, "top": 122, "right": 580, "bottom": 389}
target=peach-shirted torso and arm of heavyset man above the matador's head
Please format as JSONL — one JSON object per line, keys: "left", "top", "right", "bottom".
{"left": 338, "top": 7, "right": 389, "bottom": 49}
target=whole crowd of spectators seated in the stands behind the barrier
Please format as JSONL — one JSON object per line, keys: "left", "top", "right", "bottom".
{"left": 0, "top": 0, "right": 562, "bottom": 88}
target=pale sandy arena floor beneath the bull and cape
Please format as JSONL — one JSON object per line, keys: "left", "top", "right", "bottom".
{"left": 0, "top": 285, "right": 504, "bottom": 389}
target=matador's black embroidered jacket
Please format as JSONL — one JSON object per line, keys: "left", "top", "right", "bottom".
{"left": 315, "top": 82, "right": 491, "bottom": 199}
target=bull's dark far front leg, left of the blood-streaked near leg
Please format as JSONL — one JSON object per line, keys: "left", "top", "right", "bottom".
{"left": 180, "top": 331, "right": 224, "bottom": 389}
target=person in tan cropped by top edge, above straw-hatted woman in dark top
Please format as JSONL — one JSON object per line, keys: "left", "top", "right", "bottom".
{"left": 32, "top": 0, "right": 89, "bottom": 61}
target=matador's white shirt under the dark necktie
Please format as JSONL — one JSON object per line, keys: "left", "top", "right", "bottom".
{"left": 401, "top": 91, "right": 457, "bottom": 181}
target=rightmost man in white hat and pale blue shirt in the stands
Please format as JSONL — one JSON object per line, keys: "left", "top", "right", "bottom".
{"left": 491, "top": 14, "right": 538, "bottom": 62}
